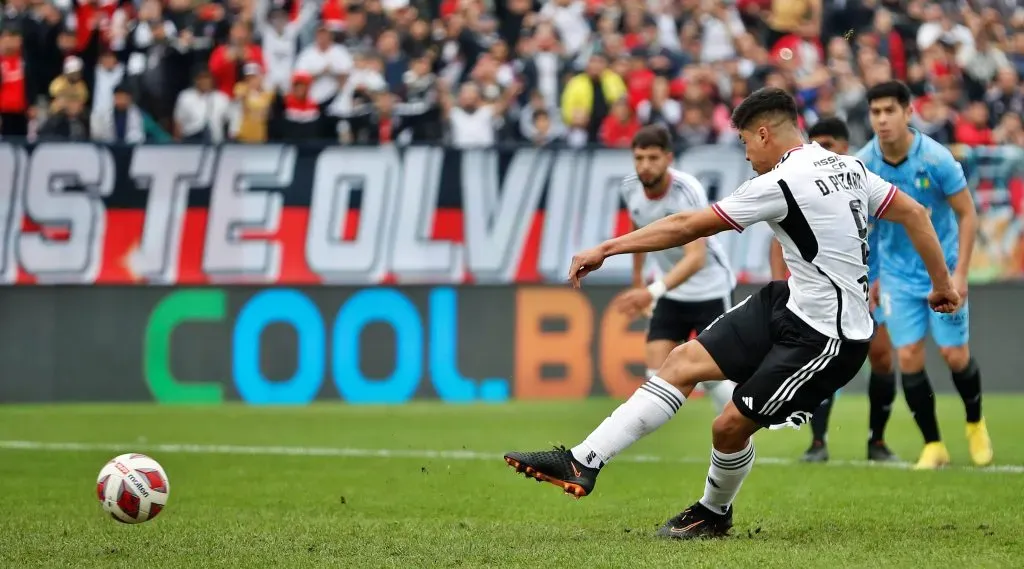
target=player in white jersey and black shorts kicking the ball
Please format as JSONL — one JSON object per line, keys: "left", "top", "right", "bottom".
{"left": 505, "top": 88, "right": 961, "bottom": 538}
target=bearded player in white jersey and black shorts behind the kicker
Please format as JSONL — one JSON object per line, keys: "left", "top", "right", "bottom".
{"left": 611, "top": 125, "right": 736, "bottom": 412}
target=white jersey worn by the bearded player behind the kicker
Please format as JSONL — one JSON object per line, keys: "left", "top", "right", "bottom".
{"left": 622, "top": 168, "right": 736, "bottom": 302}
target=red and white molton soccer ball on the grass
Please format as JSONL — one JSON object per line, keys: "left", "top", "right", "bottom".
{"left": 96, "top": 453, "right": 171, "bottom": 524}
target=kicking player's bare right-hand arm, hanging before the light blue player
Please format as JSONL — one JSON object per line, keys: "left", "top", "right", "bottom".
{"left": 877, "top": 187, "right": 961, "bottom": 312}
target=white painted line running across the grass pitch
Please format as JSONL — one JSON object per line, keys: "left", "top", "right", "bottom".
{"left": 0, "top": 440, "right": 1024, "bottom": 474}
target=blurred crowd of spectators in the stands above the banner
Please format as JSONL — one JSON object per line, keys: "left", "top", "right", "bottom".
{"left": 0, "top": 0, "right": 1024, "bottom": 147}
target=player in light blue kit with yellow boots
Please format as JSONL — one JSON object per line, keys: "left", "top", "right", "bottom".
{"left": 857, "top": 81, "right": 992, "bottom": 469}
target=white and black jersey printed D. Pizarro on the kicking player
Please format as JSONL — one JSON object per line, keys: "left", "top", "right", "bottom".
{"left": 712, "top": 143, "right": 896, "bottom": 342}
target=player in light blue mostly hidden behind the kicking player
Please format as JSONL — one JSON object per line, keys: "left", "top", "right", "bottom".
{"left": 771, "top": 118, "right": 898, "bottom": 463}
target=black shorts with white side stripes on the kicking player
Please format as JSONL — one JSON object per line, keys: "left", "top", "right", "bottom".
{"left": 697, "top": 280, "right": 868, "bottom": 427}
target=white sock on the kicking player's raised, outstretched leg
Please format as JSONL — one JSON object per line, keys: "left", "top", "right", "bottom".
{"left": 572, "top": 376, "right": 686, "bottom": 468}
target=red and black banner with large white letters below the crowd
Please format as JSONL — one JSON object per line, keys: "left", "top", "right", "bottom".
{"left": 0, "top": 143, "right": 1024, "bottom": 286}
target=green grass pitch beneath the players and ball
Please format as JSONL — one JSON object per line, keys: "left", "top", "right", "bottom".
{"left": 0, "top": 395, "right": 1024, "bottom": 569}
